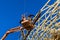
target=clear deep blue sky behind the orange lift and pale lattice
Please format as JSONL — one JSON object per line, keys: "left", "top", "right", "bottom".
{"left": 0, "top": 0, "right": 53, "bottom": 40}
